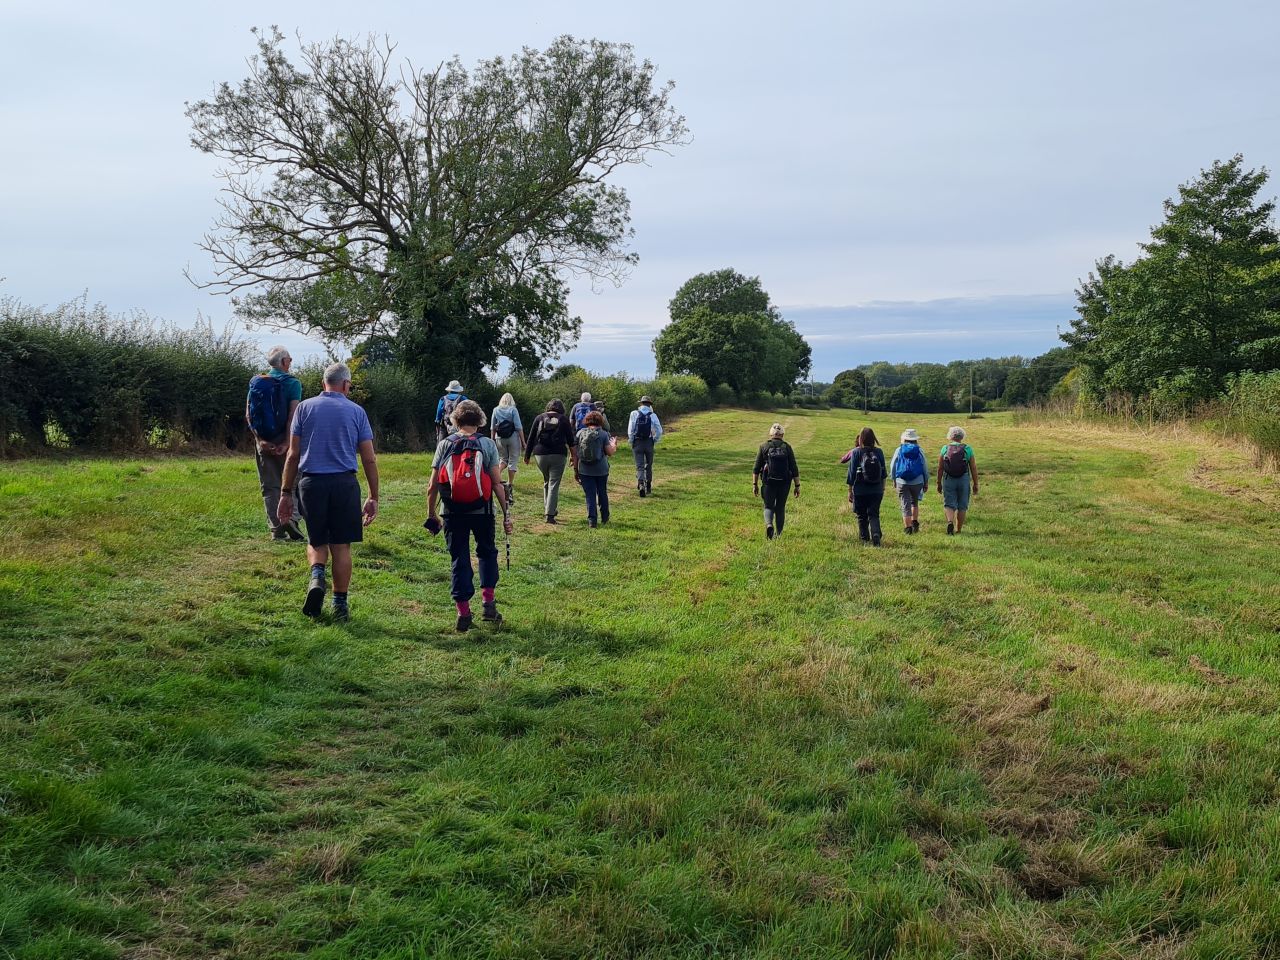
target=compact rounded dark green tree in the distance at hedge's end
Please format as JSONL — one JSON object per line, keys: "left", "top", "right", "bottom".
{"left": 653, "top": 269, "right": 812, "bottom": 393}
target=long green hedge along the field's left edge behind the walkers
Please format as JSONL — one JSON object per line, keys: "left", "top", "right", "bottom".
{"left": 0, "top": 300, "right": 788, "bottom": 456}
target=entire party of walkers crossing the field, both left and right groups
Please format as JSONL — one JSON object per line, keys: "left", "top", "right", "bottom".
{"left": 244, "top": 347, "right": 978, "bottom": 631}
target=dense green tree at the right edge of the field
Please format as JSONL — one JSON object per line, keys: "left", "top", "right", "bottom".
{"left": 1062, "top": 155, "right": 1280, "bottom": 406}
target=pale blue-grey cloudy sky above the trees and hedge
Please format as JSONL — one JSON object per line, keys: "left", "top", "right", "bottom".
{"left": 0, "top": 0, "right": 1280, "bottom": 380}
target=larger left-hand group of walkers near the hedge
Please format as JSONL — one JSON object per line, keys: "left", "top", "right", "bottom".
{"left": 244, "top": 347, "right": 662, "bottom": 631}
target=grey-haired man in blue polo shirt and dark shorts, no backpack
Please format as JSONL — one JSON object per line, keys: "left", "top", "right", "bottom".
{"left": 279, "top": 364, "right": 378, "bottom": 621}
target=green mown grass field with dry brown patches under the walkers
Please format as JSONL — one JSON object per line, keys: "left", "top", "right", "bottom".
{"left": 0, "top": 411, "right": 1280, "bottom": 960}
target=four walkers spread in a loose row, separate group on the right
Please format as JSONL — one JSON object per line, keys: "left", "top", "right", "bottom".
{"left": 751, "top": 424, "right": 978, "bottom": 547}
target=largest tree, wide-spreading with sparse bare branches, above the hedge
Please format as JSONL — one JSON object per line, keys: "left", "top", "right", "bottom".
{"left": 187, "top": 29, "right": 686, "bottom": 389}
